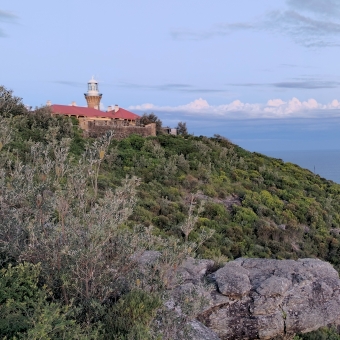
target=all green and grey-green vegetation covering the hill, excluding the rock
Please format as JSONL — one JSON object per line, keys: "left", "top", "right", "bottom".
{"left": 0, "top": 88, "right": 340, "bottom": 339}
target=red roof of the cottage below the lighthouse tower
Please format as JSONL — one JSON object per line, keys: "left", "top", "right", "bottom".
{"left": 51, "top": 104, "right": 140, "bottom": 120}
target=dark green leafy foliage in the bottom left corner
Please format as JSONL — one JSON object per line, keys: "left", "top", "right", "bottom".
{"left": 0, "top": 263, "right": 97, "bottom": 340}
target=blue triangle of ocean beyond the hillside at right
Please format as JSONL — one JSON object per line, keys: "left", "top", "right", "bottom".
{"left": 262, "top": 150, "right": 340, "bottom": 184}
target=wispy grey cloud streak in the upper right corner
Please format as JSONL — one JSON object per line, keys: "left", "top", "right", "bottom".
{"left": 170, "top": 0, "right": 340, "bottom": 47}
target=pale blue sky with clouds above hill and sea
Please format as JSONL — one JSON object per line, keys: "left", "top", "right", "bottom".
{"left": 0, "top": 0, "right": 340, "bottom": 152}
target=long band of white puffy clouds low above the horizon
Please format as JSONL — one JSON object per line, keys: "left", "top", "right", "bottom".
{"left": 129, "top": 98, "right": 340, "bottom": 119}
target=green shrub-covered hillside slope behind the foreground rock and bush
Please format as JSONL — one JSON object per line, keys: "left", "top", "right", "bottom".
{"left": 99, "top": 135, "right": 340, "bottom": 268}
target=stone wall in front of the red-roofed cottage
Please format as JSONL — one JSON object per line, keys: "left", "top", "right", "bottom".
{"left": 85, "top": 121, "right": 156, "bottom": 139}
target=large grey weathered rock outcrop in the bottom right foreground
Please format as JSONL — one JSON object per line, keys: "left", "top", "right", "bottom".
{"left": 174, "top": 259, "right": 340, "bottom": 340}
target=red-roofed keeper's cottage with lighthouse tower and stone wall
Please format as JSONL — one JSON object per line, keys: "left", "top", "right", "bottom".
{"left": 47, "top": 77, "right": 156, "bottom": 139}
